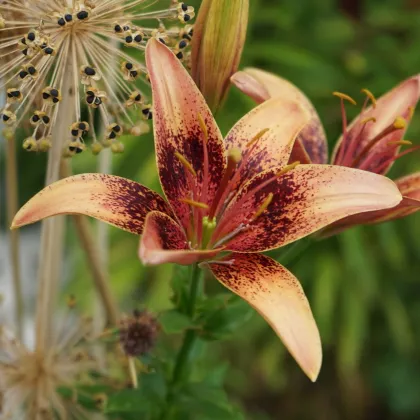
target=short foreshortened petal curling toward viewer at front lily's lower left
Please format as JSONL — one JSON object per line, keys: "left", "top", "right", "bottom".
{"left": 139, "top": 211, "right": 221, "bottom": 265}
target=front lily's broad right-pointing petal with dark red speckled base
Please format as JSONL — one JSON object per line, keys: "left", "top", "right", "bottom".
{"left": 218, "top": 165, "right": 401, "bottom": 252}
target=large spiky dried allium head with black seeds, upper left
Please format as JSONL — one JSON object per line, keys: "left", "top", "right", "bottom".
{"left": 0, "top": 0, "right": 194, "bottom": 156}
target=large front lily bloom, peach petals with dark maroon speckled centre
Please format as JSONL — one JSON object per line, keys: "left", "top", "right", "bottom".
{"left": 12, "top": 40, "right": 401, "bottom": 380}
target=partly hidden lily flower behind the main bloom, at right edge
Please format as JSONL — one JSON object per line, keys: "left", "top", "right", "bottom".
{"left": 231, "top": 68, "right": 420, "bottom": 236}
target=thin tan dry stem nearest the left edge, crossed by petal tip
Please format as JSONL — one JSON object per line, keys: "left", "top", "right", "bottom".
{"left": 4, "top": 131, "right": 23, "bottom": 339}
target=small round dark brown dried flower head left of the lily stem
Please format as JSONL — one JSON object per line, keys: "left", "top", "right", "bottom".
{"left": 120, "top": 311, "right": 159, "bottom": 357}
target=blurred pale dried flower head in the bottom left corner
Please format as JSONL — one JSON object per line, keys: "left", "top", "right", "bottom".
{"left": 0, "top": 299, "right": 104, "bottom": 420}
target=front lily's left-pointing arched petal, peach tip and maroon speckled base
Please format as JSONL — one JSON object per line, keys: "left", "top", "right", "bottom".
{"left": 12, "top": 174, "right": 172, "bottom": 234}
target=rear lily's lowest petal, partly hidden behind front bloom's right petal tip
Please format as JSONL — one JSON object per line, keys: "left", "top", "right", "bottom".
{"left": 320, "top": 172, "right": 420, "bottom": 238}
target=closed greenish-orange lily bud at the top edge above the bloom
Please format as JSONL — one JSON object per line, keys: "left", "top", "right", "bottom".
{"left": 191, "top": 0, "right": 249, "bottom": 112}
